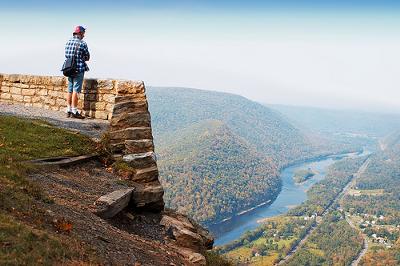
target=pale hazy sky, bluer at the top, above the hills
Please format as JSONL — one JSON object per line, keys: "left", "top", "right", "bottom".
{"left": 0, "top": 0, "right": 400, "bottom": 113}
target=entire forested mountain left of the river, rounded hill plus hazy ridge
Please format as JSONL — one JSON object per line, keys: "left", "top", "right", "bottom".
{"left": 147, "top": 88, "right": 331, "bottom": 223}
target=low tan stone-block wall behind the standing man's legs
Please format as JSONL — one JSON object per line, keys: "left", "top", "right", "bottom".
{"left": 0, "top": 74, "right": 120, "bottom": 120}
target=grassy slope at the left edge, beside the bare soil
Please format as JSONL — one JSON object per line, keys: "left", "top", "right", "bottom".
{"left": 0, "top": 116, "right": 96, "bottom": 265}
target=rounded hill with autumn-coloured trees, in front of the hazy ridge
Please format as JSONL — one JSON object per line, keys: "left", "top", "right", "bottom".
{"left": 158, "top": 120, "right": 279, "bottom": 223}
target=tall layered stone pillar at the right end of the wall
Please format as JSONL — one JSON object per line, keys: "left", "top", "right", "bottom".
{"left": 108, "top": 81, "right": 164, "bottom": 211}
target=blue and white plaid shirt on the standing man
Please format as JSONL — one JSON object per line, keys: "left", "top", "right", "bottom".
{"left": 65, "top": 36, "right": 90, "bottom": 73}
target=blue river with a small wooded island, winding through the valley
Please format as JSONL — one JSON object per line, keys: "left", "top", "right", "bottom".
{"left": 209, "top": 150, "right": 369, "bottom": 246}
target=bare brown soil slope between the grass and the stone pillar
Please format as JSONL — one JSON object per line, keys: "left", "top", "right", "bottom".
{"left": 31, "top": 161, "right": 185, "bottom": 265}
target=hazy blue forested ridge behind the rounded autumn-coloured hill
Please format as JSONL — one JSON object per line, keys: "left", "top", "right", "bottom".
{"left": 147, "top": 87, "right": 320, "bottom": 164}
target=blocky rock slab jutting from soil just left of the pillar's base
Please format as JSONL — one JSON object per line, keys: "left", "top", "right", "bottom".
{"left": 95, "top": 188, "right": 134, "bottom": 218}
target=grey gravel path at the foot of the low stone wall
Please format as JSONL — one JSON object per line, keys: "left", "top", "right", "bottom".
{"left": 0, "top": 103, "right": 109, "bottom": 139}
